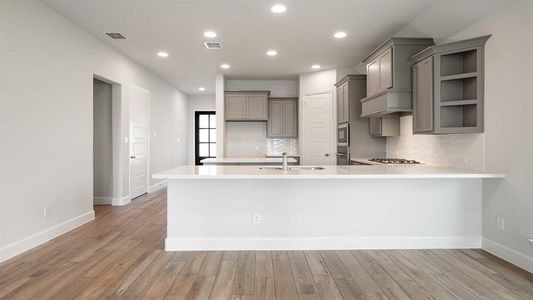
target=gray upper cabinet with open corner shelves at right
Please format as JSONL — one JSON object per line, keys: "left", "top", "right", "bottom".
{"left": 411, "top": 35, "right": 490, "bottom": 134}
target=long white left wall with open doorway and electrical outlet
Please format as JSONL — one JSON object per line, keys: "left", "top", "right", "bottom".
{"left": 0, "top": 0, "right": 187, "bottom": 261}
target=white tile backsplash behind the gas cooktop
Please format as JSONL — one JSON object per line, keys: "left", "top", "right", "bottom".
{"left": 387, "top": 116, "right": 485, "bottom": 170}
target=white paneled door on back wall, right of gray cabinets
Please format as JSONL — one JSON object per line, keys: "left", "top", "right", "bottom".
{"left": 302, "top": 92, "right": 333, "bottom": 165}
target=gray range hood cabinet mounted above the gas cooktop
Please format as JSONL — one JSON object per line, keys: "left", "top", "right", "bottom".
{"left": 361, "top": 37, "right": 434, "bottom": 117}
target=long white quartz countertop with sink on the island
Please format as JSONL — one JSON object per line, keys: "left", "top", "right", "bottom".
{"left": 152, "top": 165, "right": 505, "bottom": 179}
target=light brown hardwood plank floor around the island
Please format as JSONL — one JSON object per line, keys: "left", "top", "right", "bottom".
{"left": 0, "top": 190, "right": 533, "bottom": 300}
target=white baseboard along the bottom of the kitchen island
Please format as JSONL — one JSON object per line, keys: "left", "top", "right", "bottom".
{"left": 165, "top": 237, "right": 481, "bottom": 251}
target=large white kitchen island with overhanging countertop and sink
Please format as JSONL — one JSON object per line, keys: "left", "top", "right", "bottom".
{"left": 154, "top": 165, "right": 504, "bottom": 251}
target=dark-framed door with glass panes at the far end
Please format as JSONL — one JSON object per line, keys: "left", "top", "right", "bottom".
{"left": 194, "top": 111, "right": 217, "bottom": 166}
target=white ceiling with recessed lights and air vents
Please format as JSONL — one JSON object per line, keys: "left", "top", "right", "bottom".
{"left": 42, "top": 0, "right": 508, "bottom": 94}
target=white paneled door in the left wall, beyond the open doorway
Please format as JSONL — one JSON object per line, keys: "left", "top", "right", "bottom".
{"left": 130, "top": 87, "right": 150, "bottom": 199}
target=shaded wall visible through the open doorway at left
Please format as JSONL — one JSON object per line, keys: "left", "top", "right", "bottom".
{"left": 93, "top": 79, "right": 113, "bottom": 199}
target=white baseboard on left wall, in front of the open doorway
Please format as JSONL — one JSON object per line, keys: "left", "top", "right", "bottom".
{"left": 0, "top": 210, "right": 94, "bottom": 262}
